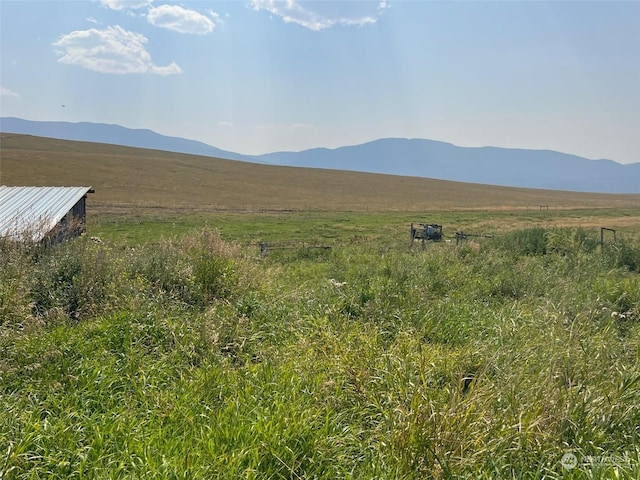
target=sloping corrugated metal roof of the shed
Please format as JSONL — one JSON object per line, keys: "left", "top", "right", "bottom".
{"left": 0, "top": 186, "right": 91, "bottom": 242}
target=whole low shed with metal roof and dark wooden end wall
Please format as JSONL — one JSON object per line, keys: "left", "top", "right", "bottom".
{"left": 0, "top": 186, "right": 94, "bottom": 243}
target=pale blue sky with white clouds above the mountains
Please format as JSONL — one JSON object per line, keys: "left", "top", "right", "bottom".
{"left": 0, "top": 0, "right": 640, "bottom": 163}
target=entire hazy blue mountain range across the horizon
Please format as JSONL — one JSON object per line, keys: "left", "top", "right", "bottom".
{"left": 0, "top": 117, "right": 640, "bottom": 193}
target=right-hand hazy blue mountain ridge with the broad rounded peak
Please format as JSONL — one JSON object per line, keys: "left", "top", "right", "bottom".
{"left": 260, "top": 138, "right": 640, "bottom": 193}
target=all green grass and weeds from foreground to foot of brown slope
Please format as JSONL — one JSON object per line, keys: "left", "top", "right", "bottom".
{"left": 0, "top": 216, "right": 640, "bottom": 480}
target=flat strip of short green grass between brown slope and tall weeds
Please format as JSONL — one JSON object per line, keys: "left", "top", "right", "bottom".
{"left": 88, "top": 208, "right": 638, "bottom": 247}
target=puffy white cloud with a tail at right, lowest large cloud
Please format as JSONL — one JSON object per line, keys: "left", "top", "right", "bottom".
{"left": 53, "top": 25, "right": 182, "bottom": 75}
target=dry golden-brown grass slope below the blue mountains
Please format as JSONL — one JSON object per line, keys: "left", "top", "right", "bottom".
{"left": 0, "top": 133, "right": 640, "bottom": 212}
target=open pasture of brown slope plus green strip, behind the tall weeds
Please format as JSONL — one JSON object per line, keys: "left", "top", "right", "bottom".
{"left": 5, "top": 133, "right": 640, "bottom": 248}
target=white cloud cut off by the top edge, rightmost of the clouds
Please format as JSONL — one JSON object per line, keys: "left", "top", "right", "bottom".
{"left": 250, "top": 0, "right": 388, "bottom": 31}
